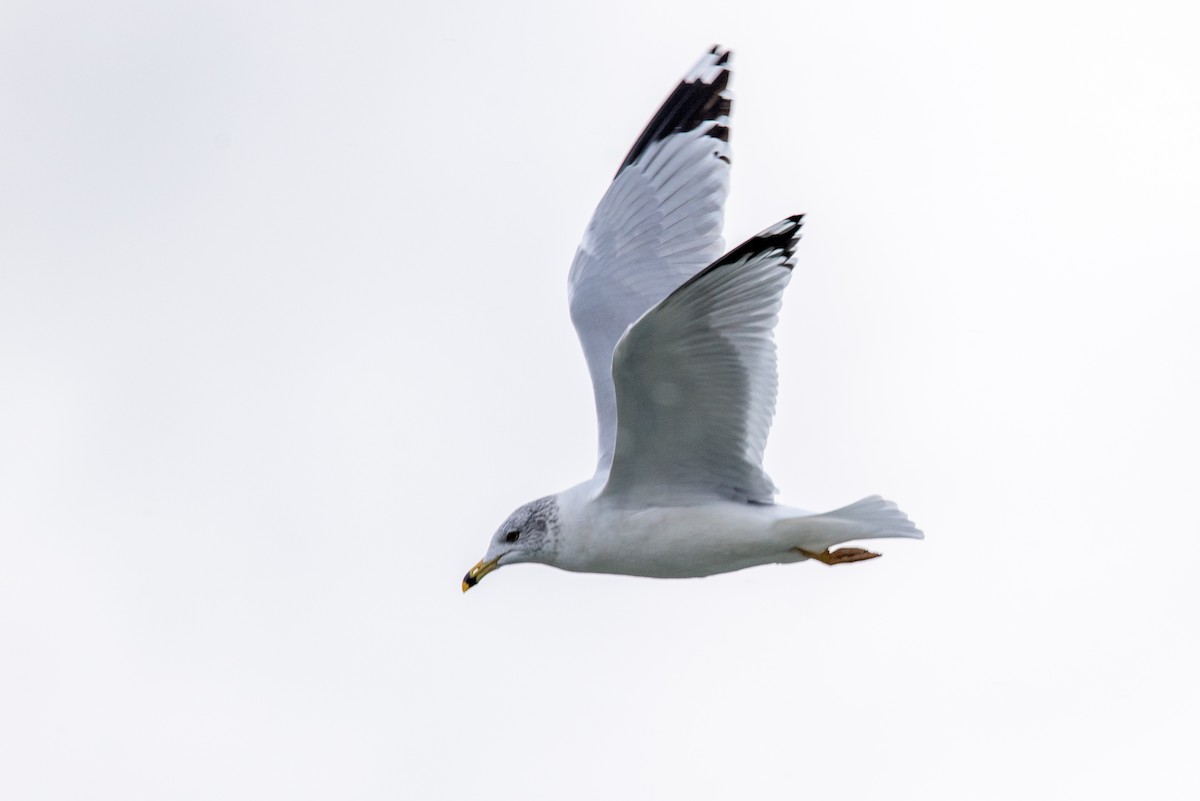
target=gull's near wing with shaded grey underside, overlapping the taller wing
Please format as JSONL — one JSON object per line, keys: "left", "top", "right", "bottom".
{"left": 604, "top": 215, "right": 803, "bottom": 506}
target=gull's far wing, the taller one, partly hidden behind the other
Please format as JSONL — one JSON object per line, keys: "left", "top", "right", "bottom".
{"left": 568, "top": 47, "right": 731, "bottom": 472}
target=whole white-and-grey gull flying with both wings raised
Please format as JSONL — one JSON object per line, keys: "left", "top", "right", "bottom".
{"left": 462, "top": 47, "right": 924, "bottom": 592}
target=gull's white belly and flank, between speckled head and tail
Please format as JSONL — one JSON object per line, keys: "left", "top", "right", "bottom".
{"left": 556, "top": 502, "right": 787, "bottom": 578}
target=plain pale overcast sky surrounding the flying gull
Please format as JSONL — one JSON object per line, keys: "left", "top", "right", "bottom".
{"left": 0, "top": 0, "right": 1200, "bottom": 801}
